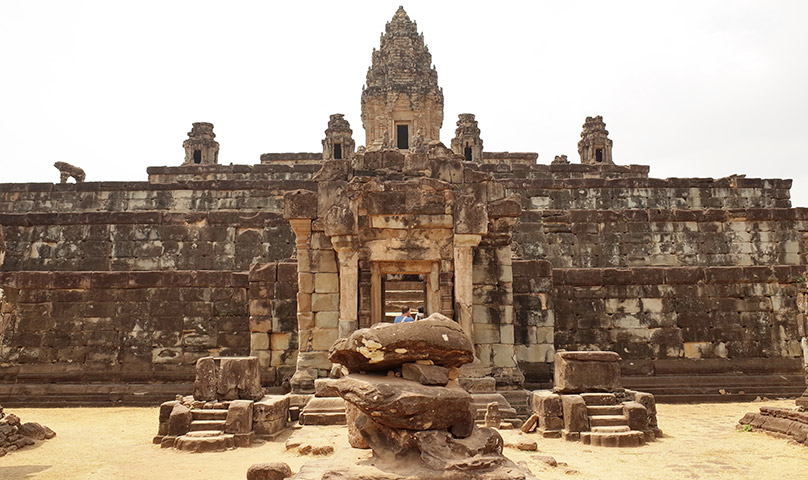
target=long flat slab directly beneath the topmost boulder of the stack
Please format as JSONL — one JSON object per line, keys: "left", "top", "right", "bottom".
{"left": 337, "top": 373, "right": 473, "bottom": 433}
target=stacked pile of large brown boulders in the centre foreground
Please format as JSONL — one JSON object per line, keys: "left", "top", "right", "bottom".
{"left": 294, "top": 314, "right": 534, "bottom": 480}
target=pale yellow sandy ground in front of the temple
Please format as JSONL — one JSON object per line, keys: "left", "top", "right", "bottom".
{"left": 0, "top": 401, "right": 808, "bottom": 480}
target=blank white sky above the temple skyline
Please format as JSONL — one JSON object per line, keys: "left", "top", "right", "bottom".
{"left": 0, "top": 0, "right": 808, "bottom": 206}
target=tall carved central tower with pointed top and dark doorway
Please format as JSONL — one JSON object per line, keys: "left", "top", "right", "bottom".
{"left": 362, "top": 7, "right": 443, "bottom": 150}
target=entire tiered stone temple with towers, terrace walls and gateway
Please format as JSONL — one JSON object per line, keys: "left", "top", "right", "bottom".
{"left": 0, "top": 5, "right": 808, "bottom": 406}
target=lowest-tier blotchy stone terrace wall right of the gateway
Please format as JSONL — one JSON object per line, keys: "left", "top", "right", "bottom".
{"left": 553, "top": 266, "right": 806, "bottom": 375}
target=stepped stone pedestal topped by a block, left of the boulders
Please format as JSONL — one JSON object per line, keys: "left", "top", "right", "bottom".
{"left": 154, "top": 357, "right": 289, "bottom": 452}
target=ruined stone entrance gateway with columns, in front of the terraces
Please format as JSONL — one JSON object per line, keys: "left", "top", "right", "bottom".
{"left": 284, "top": 142, "right": 521, "bottom": 391}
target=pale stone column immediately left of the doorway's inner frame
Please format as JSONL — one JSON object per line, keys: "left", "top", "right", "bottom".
{"left": 331, "top": 235, "right": 359, "bottom": 338}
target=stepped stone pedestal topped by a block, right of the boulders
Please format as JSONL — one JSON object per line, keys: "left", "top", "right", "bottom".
{"left": 522, "top": 350, "right": 662, "bottom": 447}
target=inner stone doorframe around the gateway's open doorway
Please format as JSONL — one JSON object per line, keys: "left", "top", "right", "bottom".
{"left": 370, "top": 260, "right": 441, "bottom": 325}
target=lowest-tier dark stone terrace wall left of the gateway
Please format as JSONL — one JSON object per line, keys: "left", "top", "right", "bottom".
{"left": 0, "top": 271, "right": 249, "bottom": 383}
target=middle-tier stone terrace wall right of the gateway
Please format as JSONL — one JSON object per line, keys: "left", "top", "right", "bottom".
{"left": 514, "top": 208, "right": 808, "bottom": 268}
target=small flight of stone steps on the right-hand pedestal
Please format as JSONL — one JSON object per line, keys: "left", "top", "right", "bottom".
{"left": 581, "top": 393, "right": 654, "bottom": 447}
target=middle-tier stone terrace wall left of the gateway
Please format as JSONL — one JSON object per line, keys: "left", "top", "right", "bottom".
{"left": 0, "top": 211, "right": 294, "bottom": 271}
